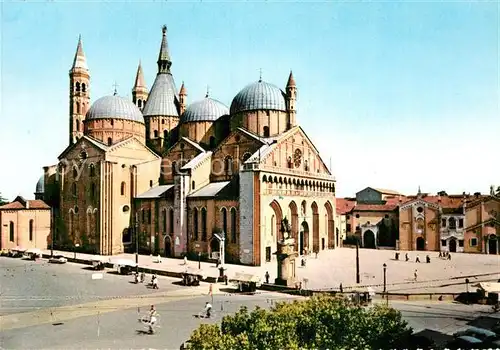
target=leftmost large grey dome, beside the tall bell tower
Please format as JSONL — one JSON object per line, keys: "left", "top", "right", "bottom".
{"left": 86, "top": 95, "right": 144, "bottom": 124}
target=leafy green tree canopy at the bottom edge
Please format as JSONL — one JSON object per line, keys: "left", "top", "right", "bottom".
{"left": 189, "top": 296, "right": 412, "bottom": 350}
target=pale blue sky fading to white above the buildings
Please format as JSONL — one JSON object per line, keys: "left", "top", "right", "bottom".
{"left": 0, "top": 1, "right": 500, "bottom": 199}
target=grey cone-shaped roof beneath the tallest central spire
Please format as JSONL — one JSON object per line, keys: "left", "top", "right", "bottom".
{"left": 142, "top": 73, "right": 179, "bottom": 117}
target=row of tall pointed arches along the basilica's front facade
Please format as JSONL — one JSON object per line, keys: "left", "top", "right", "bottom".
{"left": 268, "top": 199, "right": 338, "bottom": 260}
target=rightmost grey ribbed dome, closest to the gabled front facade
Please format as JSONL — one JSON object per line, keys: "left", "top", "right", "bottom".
{"left": 231, "top": 80, "right": 286, "bottom": 114}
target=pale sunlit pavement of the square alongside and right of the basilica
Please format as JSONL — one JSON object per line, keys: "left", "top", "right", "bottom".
{"left": 41, "top": 248, "right": 500, "bottom": 293}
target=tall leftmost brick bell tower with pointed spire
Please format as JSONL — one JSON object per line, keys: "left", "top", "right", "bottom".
{"left": 69, "top": 36, "right": 90, "bottom": 145}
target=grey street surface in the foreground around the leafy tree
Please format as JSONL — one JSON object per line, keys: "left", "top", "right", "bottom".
{"left": 0, "top": 256, "right": 500, "bottom": 349}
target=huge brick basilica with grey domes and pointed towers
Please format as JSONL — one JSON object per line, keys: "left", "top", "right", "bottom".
{"left": 35, "top": 26, "right": 342, "bottom": 266}
